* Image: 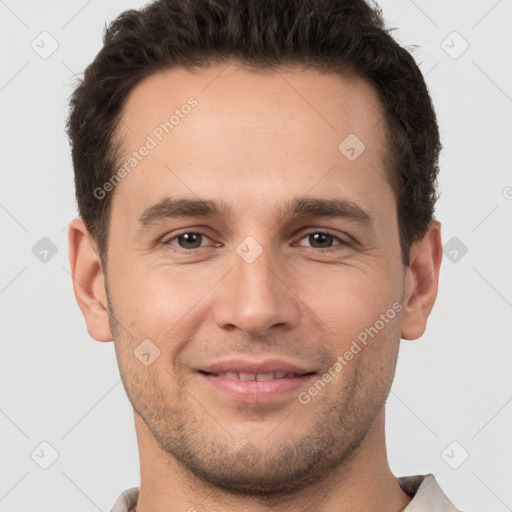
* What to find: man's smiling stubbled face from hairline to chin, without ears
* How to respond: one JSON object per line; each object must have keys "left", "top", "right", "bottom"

{"left": 108, "top": 66, "right": 404, "bottom": 492}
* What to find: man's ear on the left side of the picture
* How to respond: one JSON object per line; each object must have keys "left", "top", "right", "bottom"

{"left": 68, "top": 218, "right": 113, "bottom": 341}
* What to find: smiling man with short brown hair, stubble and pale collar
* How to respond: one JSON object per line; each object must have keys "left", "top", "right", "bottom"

{"left": 64, "top": 0, "right": 456, "bottom": 512}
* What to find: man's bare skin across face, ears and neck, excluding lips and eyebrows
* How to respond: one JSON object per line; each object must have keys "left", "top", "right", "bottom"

{"left": 69, "top": 63, "right": 442, "bottom": 512}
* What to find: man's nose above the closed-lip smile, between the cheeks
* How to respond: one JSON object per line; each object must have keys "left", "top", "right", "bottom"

{"left": 214, "top": 242, "right": 300, "bottom": 336}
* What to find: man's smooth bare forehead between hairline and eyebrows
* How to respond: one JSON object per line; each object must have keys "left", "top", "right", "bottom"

{"left": 114, "top": 64, "right": 390, "bottom": 224}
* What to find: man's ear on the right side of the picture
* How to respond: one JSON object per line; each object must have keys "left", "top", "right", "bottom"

{"left": 402, "top": 219, "right": 443, "bottom": 340}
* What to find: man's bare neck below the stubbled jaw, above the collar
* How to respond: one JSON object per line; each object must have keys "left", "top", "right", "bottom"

{"left": 131, "top": 408, "right": 411, "bottom": 512}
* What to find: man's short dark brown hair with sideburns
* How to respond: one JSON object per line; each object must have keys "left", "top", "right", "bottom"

{"left": 66, "top": 0, "right": 442, "bottom": 266}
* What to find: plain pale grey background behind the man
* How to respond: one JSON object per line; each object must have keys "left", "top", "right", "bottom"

{"left": 0, "top": 0, "right": 512, "bottom": 512}
